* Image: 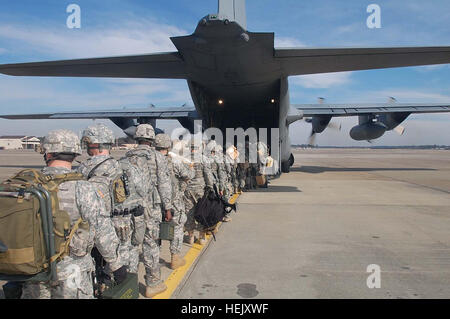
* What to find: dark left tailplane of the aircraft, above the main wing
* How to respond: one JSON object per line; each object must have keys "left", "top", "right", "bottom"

{"left": 0, "top": 52, "right": 186, "bottom": 79}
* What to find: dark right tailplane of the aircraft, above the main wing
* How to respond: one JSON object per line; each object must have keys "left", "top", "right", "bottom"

{"left": 275, "top": 46, "right": 450, "bottom": 76}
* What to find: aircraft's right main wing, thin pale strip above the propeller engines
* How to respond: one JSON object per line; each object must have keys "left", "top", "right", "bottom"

{"left": 292, "top": 103, "right": 450, "bottom": 117}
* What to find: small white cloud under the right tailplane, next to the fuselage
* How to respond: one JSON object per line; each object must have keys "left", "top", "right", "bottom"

{"left": 292, "top": 72, "right": 352, "bottom": 89}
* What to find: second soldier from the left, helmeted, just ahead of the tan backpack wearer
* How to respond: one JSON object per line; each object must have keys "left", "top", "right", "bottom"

{"left": 78, "top": 124, "right": 139, "bottom": 273}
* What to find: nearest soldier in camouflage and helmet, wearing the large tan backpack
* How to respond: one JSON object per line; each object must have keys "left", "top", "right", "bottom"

{"left": 22, "top": 130, "right": 127, "bottom": 299}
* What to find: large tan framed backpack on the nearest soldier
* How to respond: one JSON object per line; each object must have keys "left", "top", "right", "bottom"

{"left": 0, "top": 169, "right": 89, "bottom": 281}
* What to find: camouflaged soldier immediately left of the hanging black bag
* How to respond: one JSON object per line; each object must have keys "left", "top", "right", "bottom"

{"left": 185, "top": 139, "right": 214, "bottom": 245}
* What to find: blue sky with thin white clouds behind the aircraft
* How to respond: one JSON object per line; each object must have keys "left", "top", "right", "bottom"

{"left": 0, "top": 0, "right": 450, "bottom": 145}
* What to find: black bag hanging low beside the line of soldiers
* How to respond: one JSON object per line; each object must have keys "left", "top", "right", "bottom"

{"left": 194, "top": 185, "right": 236, "bottom": 230}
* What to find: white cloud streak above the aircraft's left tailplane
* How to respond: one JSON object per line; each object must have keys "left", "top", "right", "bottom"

{"left": 0, "top": 20, "right": 187, "bottom": 58}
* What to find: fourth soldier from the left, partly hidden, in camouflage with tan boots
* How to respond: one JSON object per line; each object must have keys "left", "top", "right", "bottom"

{"left": 155, "top": 134, "right": 194, "bottom": 269}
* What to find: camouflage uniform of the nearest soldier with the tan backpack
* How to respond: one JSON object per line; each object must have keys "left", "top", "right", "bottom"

{"left": 22, "top": 167, "right": 123, "bottom": 299}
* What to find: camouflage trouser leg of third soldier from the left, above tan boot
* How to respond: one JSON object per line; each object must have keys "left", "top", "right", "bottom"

{"left": 142, "top": 208, "right": 162, "bottom": 287}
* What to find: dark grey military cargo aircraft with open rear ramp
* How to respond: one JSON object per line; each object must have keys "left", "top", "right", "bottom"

{"left": 0, "top": 0, "right": 450, "bottom": 173}
